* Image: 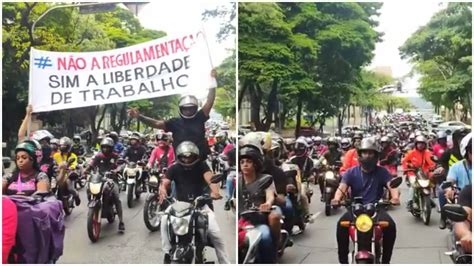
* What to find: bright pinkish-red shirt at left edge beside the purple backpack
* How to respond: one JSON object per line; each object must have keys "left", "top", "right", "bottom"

{"left": 2, "top": 196, "right": 18, "bottom": 264}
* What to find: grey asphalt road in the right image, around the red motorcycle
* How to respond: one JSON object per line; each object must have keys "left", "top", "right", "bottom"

{"left": 279, "top": 172, "right": 452, "bottom": 264}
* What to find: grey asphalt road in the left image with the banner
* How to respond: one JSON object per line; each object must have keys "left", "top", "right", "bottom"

{"left": 58, "top": 185, "right": 236, "bottom": 264}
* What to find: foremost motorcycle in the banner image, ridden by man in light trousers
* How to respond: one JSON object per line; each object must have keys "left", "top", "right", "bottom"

{"left": 159, "top": 176, "right": 220, "bottom": 264}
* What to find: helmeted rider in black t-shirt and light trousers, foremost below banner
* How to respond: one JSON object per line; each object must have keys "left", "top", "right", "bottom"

{"left": 160, "top": 141, "right": 230, "bottom": 264}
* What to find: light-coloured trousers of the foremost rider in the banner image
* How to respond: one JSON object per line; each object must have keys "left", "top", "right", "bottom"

{"left": 160, "top": 205, "right": 230, "bottom": 264}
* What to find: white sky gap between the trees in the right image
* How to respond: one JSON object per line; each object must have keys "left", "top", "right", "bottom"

{"left": 369, "top": 1, "right": 446, "bottom": 96}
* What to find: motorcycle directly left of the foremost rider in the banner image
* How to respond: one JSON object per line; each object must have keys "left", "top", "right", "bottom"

{"left": 143, "top": 168, "right": 171, "bottom": 232}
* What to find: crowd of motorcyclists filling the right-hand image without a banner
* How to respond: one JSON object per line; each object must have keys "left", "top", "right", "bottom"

{"left": 238, "top": 114, "right": 472, "bottom": 263}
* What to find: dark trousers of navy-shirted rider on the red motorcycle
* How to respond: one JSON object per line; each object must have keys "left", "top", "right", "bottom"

{"left": 336, "top": 211, "right": 397, "bottom": 264}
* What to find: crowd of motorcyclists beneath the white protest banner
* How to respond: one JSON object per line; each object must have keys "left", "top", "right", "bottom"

{"left": 3, "top": 70, "right": 241, "bottom": 263}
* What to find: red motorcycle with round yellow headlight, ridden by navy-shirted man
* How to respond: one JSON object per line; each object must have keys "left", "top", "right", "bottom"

{"left": 340, "top": 177, "right": 402, "bottom": 264}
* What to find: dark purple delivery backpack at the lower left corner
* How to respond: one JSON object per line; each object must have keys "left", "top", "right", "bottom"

{"left": 9, "top": 193, "right": 65, "bottom": 264}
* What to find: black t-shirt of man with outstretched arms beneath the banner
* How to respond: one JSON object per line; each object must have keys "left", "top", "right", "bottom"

{"left": 165, "top": 109, "right": 211, "bottom": 160}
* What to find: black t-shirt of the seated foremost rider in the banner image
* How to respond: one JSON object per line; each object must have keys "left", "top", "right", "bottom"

{"left": 166, "top": 162, "right": 211, "bottom": 202}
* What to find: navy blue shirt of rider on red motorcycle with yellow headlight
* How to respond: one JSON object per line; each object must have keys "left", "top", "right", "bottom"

{"left": 341, "top": 166, "right": 392, "bottom": 204}
